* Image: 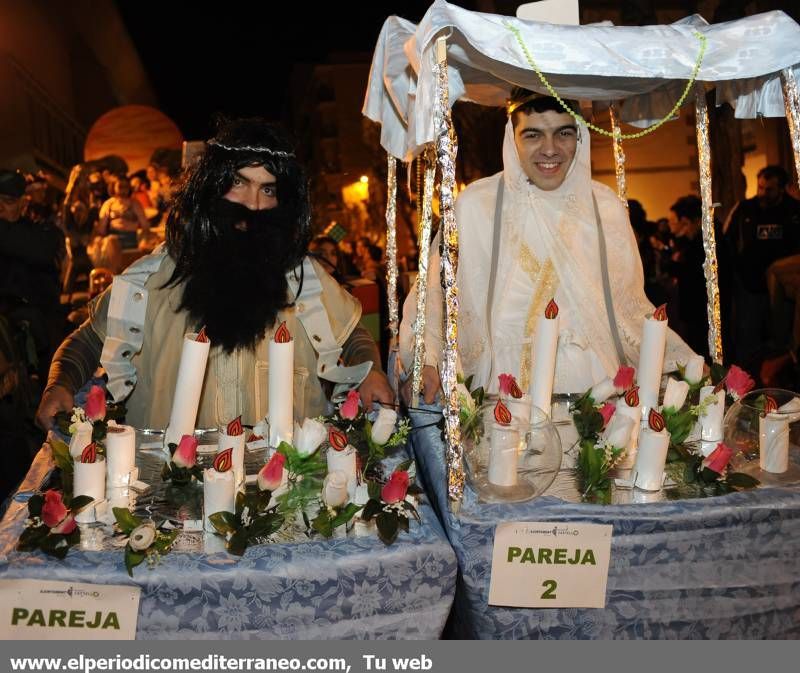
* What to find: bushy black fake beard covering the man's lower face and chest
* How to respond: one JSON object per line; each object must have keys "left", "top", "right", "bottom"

{"left": 181, "top": 199, "right": 296, "bottom": 352}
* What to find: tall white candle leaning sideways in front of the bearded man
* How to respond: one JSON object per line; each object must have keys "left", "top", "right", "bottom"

{"left": 164, "top": 333, "right": 211, "bottom": 446}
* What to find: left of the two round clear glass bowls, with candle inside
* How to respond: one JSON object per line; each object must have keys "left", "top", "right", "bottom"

{"left": 464, "top": 397, "right": 561, "bottom": 503}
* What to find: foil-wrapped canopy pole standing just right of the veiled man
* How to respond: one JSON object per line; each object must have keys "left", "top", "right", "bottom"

{"left": 695, "top": 84, "right": 722, "bottom": 364}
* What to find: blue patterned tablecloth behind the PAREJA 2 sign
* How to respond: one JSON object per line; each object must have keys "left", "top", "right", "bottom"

{"left": 412, "top": 412, "right": 800, "bottom": 639}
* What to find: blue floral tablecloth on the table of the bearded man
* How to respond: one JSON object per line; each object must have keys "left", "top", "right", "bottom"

{"left": 0, "top": 438, "right": 457, "bottom": 640}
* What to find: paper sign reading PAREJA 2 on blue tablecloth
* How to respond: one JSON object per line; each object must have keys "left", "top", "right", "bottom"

{"left": 489, "top": 521, "right": 612, "bottom": 608}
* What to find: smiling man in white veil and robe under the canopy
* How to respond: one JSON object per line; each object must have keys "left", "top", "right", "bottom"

{"left": 400, "top": 88, "right": 693, "bottom": 403}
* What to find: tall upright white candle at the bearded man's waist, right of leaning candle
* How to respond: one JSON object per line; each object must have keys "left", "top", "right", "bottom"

{"left": 268, "top": 322, "right": 294, "bottom": 446}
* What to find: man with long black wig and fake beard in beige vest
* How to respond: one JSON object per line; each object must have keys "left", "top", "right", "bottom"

{"left": 37, "top": 119, "right": 394, "bottom": 428}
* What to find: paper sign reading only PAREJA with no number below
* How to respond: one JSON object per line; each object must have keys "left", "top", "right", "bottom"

{"left": 0, "top": 579, "right": 140, "bottom": 640}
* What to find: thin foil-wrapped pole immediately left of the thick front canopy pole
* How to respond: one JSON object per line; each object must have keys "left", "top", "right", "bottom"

{"left": 411, "top": 148, "right": 441, "bottom": 407}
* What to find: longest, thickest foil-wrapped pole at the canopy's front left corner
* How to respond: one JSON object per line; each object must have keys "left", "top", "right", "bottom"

{"left": 433, "top": 37, "right": 464, "bottom": 511}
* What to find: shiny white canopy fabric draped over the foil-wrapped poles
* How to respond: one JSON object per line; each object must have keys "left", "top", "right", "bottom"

{"left": 363, "top": 0, "right": 800, "bottom": 159}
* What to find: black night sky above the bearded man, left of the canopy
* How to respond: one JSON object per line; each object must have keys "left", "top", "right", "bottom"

{"left": 112, "top": 0, "right": 472, "bottom": 139}
